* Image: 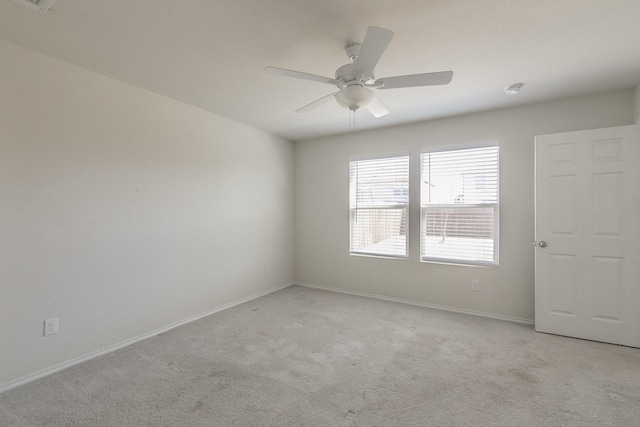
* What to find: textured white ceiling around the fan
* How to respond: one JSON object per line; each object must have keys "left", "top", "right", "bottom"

{"left": 0, "top": 0, "right": 640, "bottom": 140}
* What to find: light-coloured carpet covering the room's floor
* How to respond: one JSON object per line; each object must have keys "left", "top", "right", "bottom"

{"left": 0, "top": 286, "right": 640, "bottom": 427}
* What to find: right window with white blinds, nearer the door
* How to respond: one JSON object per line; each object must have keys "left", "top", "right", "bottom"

{"left": 421, "top": 146, "right": 499, "bottom": 265}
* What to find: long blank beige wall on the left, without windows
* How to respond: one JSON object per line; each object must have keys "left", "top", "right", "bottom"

{"left": 0, "top": 42, "right": 294, "bottom": 389}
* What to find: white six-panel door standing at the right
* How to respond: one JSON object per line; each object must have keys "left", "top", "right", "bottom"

{"left": 535, "top": 126, "right": 640, "bottom": 347}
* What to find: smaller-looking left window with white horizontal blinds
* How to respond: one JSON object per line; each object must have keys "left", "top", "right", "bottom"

{"left": 349, "top": 155, "right": 409, "bottom": 258}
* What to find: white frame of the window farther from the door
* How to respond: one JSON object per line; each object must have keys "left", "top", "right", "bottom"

{"left": 348, "top": 152, "right": 411, "bottom": 260}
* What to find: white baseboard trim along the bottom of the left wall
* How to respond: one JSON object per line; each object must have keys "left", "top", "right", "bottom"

{"left": 0, "top": 283, "right": 293, "bottom": 393}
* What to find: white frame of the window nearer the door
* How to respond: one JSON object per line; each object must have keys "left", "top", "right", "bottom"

{"left": 419, "top": 142, "right": 500, "bottom": 267}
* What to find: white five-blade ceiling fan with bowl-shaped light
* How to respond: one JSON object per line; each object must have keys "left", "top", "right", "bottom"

{"left": 264, "top": 27, "right": 453, "bottom": 117}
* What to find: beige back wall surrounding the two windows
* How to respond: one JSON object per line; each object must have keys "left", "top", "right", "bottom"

{"left": 295, "top": 91, "right": 633, "bottom": 320}
